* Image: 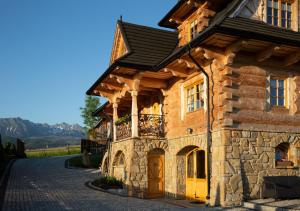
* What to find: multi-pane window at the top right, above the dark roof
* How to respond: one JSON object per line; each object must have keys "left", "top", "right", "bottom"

{"left": 267, "top": 0, "right": 292, "bottom": 29}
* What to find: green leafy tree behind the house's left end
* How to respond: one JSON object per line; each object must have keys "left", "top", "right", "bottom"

{"left": 80, "top": 96, "right": 100, "bottom": 135}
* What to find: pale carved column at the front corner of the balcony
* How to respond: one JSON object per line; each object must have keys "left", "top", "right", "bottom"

{"left": 131, "top": 91, "right": 139, "bottom": 138}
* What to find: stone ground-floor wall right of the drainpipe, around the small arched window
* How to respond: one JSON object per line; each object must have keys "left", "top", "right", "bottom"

{"left": 211, "top": 130, "right": 300, "bottom": 206}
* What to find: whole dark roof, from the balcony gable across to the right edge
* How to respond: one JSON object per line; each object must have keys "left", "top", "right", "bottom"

{"left": 87, "top": 0, "right": 300, "bottom": 94}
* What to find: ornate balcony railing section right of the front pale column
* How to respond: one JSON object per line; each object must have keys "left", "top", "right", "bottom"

{"left": 139, "top": 114, "right": 165, "bottom": 137}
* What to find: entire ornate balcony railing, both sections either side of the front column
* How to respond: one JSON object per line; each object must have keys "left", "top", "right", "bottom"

{"left": 115, "top": 114, "right": 165, "bottom": 140}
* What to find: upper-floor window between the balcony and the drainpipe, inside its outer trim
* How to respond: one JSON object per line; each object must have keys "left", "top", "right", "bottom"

{"left": 187, "top": 83, "right": 204, "bottom": 112}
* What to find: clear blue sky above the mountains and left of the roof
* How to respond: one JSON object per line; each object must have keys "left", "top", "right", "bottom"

{"left": 0, "top": 0, "right": 177, "bottom": 124}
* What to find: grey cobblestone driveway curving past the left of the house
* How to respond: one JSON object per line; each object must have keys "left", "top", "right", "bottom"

{"left": 2, "top": 157, "right": 182, "bottom": 211}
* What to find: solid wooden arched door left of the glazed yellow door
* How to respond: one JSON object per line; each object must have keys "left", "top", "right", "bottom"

{"left": 147, "top": 149, "right": 165, "bottom": 198}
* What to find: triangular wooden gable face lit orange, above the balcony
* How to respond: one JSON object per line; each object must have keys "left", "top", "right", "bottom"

{"left": 110, "top": 24, "right": 128, "bottom": 64}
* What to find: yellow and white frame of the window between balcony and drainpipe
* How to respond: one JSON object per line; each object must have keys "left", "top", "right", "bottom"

{"left": 185, "top": 81, "right": 205, "bottom": 113}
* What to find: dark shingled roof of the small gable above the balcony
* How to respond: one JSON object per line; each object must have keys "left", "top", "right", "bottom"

{"left": 87, "top": 21, "right": 178, "bottom": 94}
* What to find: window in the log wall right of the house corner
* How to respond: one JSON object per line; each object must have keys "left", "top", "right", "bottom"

{"left": 270, "top": 78, "right": 285, "bottom": 106}
